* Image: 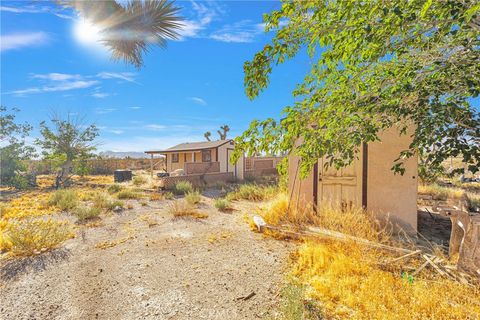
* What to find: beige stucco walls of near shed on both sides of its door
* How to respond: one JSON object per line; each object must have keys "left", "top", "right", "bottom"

{"left": 288, "top": 128, "right": 418, "bottom": 233}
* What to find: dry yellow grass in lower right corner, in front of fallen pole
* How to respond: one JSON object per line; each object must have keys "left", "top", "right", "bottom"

{"left": 291, "top": 242, "right": 480, "bottom": 320}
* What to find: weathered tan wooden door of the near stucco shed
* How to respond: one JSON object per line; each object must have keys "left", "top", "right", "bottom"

{"left": 317, "top": 154, "right": 362, "bottom": 211}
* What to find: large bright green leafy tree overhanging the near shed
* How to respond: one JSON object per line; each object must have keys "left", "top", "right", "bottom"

{"left": 236, "top": 0, "right": 480, "bottom": 176}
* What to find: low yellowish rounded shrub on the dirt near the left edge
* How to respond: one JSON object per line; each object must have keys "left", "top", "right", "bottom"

{"left": 6, "top": 219, "right": 74, "bottom": 256}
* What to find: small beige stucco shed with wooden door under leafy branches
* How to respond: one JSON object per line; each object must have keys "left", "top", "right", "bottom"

{"left": 288, "top": 128, "right": 418, "bottom": 233}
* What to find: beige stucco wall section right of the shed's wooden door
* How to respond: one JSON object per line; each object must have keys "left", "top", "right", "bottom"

{"left": 367, "top": 129, "right": 418, "bottom": 233}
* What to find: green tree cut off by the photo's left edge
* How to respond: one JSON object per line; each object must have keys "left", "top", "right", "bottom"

{"left": 0, "top": 106, "right": 35, "bottom": 188}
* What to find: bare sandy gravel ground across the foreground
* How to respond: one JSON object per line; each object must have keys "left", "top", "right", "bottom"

{"left": 0, "top": 197, "right": 293, "bottom": 319}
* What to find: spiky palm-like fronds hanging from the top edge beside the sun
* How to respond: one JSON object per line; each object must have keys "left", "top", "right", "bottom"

{"left": 57, "top": 0, "right": 182, "bottom": 68}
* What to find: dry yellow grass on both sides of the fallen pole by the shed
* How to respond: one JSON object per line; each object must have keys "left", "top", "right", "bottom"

{"left": 260, "top": 195, "right": 480, "bottom": 319}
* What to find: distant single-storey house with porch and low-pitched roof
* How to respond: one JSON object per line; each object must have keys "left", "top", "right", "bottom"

{"left": 145, "top": 140, "right": 245, "bottom": 186}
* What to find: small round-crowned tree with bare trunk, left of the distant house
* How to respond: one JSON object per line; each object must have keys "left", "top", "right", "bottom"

{"left": 35, "top": 116, "right": 98, "bottom": 188}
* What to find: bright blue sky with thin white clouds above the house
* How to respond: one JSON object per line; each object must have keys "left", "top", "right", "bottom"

{"left": 0, "top": 0, "right": 309, "bottom": 151}
